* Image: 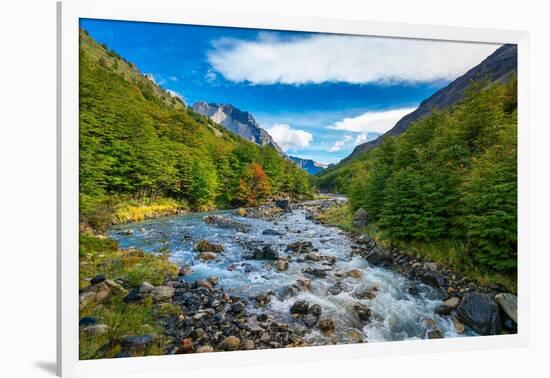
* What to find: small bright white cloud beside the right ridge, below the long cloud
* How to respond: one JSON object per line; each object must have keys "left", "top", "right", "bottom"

{"left": 328, "top": 108, "right": 416, "bottom": 134}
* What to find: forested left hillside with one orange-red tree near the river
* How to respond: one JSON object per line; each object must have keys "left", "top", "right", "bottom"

{"left": 80, "top": 30, "right": 310, "bottom": 228}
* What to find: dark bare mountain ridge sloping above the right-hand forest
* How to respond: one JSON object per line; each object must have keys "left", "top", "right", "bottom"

{"left": 343, "top": 45, "right": 517, "bottom": 161}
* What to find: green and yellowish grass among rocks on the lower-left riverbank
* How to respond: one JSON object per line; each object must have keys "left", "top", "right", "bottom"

{"left": 79, "top": 234, "right": 181, "bottom": 359}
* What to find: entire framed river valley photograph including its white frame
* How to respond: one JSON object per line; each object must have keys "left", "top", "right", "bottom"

{"left": 58, "top": 0, "right": 529, "bottom": 376}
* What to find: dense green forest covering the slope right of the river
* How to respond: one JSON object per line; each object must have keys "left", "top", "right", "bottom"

{"left": 316, "top": 79, "right": 517, "bottom": 274}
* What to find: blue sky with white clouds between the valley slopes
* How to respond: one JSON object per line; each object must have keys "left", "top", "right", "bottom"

{"left": 81, "top": 19, "right": 498, "bottom": 163}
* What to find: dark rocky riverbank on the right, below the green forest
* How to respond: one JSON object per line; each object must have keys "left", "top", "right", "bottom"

{"left": 308, "top": 199, "right": 517, "bottom": 336}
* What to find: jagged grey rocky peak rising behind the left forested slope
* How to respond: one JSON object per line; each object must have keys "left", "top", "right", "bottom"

{"left": 193, "top": 101, "right": 285, "bottom": 156}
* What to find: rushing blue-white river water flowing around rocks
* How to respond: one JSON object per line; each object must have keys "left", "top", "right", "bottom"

{"left": 109, "top": 202, "right": 472, "bottom": 345}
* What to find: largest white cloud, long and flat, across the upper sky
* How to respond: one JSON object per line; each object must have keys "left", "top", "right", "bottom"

{"left": 208, "top": 33, "right": 498, "bottom": 84}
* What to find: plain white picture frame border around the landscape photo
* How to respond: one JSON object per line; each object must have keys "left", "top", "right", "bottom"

{"left": 57, "top": 0, "right": 529, "bottom": 376}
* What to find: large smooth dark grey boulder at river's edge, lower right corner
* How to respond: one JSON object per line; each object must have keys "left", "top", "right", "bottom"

{"left": 456, "top": 292, "right": 500, "bottom": 335}
